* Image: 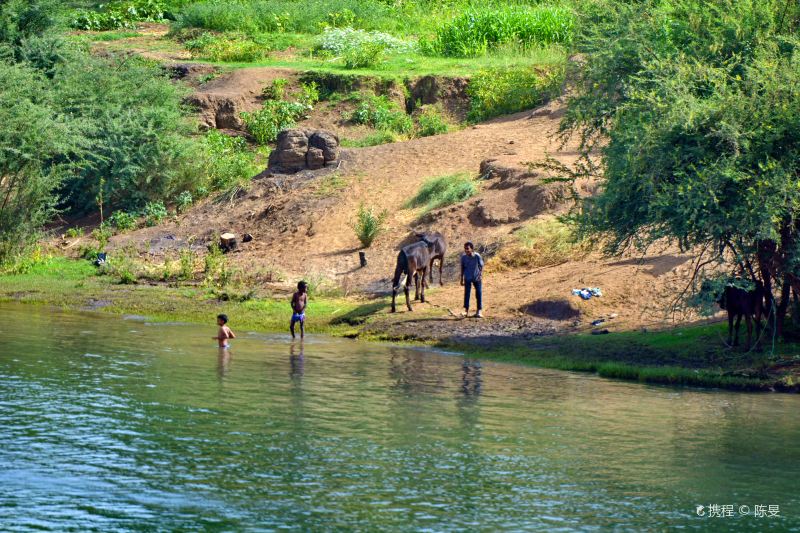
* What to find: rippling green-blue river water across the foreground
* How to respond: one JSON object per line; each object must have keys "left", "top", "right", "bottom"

{"left": 0, "top": 304, "right": 800, "bottom": 531}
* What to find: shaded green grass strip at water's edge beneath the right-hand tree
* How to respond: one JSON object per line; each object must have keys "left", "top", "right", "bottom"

{"left": 447, "top": 324, "right": 800, "bottom": 390}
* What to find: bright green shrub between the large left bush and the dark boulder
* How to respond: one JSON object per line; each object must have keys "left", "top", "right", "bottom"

{"left": 202, "top": 130, "right": 258, "bottom": 190}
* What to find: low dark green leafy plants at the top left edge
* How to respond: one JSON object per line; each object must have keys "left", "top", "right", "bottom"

{"left": 70, "top": 0, "right": 167, "bottom": 31}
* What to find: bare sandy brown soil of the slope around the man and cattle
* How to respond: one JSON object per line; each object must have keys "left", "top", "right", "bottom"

{"left": 113, "top": 85, "right": 691, "bottom": 339}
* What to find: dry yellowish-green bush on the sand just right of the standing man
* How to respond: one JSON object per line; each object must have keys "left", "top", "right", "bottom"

{"left": 492, "top": 218, "right": 589, "bottom": 270}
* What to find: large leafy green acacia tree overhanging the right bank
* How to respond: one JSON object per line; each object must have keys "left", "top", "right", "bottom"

{"left": 562, "top": 0, "right": 800, "bottom": 328}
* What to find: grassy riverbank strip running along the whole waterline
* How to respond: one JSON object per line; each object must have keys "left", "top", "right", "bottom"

{"left": 0, "top": 257, "right": 800, "bottom": 392}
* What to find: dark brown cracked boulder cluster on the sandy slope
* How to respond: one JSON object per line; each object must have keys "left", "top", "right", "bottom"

{"left": 268, "top": 129, "right": 339, "bottom": 174}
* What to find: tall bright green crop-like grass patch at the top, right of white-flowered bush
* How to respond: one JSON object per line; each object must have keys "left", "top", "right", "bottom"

{"left": 425, "top": 5, "right": 575, "bottom": 57}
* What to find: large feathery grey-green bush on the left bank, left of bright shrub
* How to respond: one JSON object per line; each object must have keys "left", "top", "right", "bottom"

{"left": 56, "top": 54, "right": 196, "bottom": 213}
